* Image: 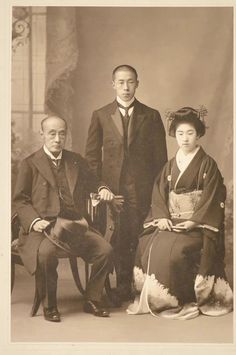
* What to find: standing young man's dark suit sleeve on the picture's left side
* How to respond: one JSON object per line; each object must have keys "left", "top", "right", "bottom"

{"left": 85, "top": 111, "right": 103, "bottom": 178}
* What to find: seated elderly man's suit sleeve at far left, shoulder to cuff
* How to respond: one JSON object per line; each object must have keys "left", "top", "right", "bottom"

{"left": 13, "top": 160, "right": 40, "bottom": 233}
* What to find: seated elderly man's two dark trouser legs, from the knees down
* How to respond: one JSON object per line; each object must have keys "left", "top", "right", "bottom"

{"left": 35, "top": 230, "right": 113, "bottom": 308}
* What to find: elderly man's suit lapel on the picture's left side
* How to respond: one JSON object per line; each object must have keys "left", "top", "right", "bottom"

{"left": 32, "top": 148, "right": 56, "bottom": 187}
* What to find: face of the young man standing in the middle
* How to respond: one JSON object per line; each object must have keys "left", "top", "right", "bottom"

{"left": 112, "top": 70, "right": 138, "bottom": 101}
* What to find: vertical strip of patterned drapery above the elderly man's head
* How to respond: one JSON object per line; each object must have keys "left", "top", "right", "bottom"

{"left": 45, "top": 7, "right": 78, "bottom": 134}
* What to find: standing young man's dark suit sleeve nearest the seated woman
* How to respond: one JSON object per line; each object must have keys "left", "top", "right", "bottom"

{"left": 151, "top": 111, "right": 167, "bottom": 176}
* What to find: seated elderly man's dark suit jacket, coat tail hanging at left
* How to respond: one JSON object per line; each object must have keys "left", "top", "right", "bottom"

{"left": 13, "top": 149, "right": 104, "bottom": 273}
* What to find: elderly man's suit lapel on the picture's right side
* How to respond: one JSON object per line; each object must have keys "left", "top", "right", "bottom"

{"left": 62, "top": 150, "right": 79, "bottom": 196}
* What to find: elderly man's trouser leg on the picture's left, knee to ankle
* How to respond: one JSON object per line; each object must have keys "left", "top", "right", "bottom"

{"left": 35, "top": 238, "right": 58, "bottom": 308}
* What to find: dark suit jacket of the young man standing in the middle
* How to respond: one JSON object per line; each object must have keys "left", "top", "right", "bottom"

{"left": 85, "top": 100, "right": 167, "bottom": 217}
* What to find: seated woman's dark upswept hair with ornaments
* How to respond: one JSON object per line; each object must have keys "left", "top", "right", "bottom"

{"left": 169, "top": 107, "right": 206, "bottom": 137}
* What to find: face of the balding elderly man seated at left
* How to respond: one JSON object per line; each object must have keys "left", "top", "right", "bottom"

{"left": 41, "top": 117, "right": 66, "bottom": 156}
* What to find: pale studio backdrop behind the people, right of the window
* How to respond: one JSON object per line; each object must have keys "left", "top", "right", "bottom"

{"left": 13, "top": 7, "right": 233, "bottom": 284}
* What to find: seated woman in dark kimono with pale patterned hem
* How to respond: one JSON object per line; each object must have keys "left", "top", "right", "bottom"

{"left": 127, "top": 107, "right": 233, "bottom": 319}
